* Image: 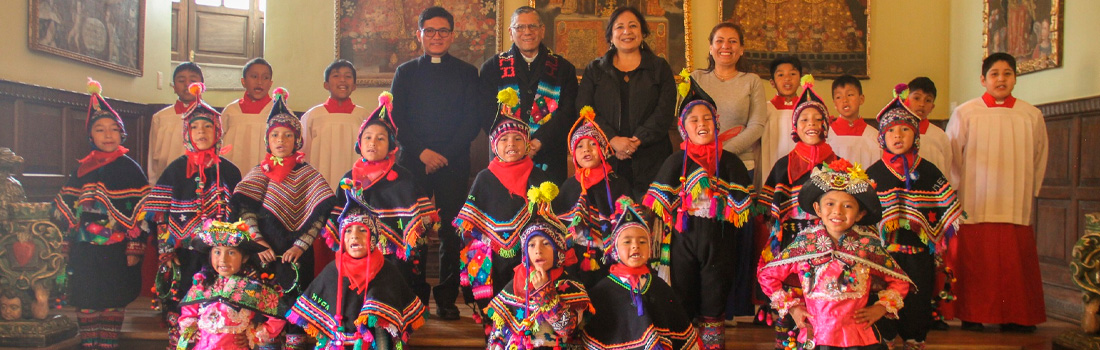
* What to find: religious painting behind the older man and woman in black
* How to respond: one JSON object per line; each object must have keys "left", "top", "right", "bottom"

{"left": 530, "top": 0, "right": 691, "bottom": 75}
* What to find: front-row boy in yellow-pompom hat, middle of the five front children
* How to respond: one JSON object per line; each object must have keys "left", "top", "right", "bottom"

{"left": 485, "top": 209, "right": 592, "bottom": 350}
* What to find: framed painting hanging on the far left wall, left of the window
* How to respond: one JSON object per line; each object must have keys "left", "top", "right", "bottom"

{"left": 26, "top": 0, "right": 145, "bottom": 76}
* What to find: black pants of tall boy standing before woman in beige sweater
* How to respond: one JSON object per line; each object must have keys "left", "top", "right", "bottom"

{"left": 669, "top": 217, "right": 737, "bottom": 319}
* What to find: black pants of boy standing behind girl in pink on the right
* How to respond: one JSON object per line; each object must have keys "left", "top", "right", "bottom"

{"left": 875, "top": 251, "right": 936, "bottom": 342}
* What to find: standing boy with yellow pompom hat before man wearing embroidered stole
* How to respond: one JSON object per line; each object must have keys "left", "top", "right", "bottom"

{"left": 453, "top": 88, "right": 554, "bottom": 322}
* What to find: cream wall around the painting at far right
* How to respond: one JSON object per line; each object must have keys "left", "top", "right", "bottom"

{"left": 949, "top": 0, "right": 1100, "bottom": 105}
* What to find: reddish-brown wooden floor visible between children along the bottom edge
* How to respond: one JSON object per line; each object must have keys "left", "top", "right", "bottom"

{"left": 45, "top": 298, "right": 1076, "bottom": 350}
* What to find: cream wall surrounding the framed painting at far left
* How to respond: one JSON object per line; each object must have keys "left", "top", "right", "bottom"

{"left": 0, "top": 0, "right": 175, "bottom": 103}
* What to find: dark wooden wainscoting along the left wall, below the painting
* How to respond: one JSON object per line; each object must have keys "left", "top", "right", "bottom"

{"left": 0, "top": 80, "right": 160, "bottom": 201}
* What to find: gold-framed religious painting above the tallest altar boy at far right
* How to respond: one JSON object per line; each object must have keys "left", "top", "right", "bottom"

{"left": 981, "top": 0, "right": 1063, "bottom": 74}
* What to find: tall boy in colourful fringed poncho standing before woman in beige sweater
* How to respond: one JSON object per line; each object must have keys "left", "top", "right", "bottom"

{"left": 644, "top": 79, "right": 755, "bottom": 349}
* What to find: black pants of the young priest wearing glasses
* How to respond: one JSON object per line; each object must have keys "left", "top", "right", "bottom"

{"left": 403, "top": 155, "right": 470, "bottom": 309}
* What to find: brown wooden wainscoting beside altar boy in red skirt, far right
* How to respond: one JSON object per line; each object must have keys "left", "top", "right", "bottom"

{"left": 1033, "top": 96, "right": 1100, "bottom": 324}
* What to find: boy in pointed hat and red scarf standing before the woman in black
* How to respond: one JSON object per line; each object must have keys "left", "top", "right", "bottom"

{"left": 553, "top": 106, "right": 630, "bottom": 286}
